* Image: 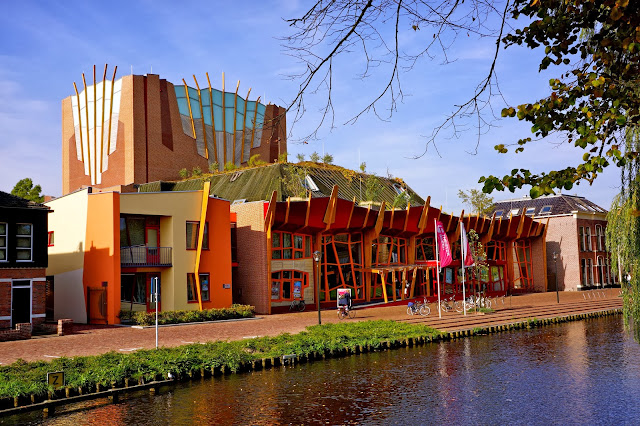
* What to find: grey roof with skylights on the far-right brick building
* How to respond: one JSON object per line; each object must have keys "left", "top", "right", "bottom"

{"left": 492, "top": 194, "right": 607, "bottom": 217}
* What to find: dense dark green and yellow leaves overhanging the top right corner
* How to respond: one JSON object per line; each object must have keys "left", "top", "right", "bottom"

{"left": 481, "top": 0, "right": 640, "bottom": 198}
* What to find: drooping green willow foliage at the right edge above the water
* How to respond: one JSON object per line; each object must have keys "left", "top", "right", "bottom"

{"left": 605, "top": 129, "right": 640, "bottom": 342}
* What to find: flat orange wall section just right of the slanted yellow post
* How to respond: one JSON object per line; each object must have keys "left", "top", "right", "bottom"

{"left": 199, "top": 198, "right": 232, "bottom": 309}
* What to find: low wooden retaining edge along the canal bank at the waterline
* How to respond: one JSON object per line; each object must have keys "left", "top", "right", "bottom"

{"left": 0, "top": 309, "right": 622, "bottom": 416}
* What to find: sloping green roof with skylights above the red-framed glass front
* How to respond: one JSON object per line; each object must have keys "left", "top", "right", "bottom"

{"left": 138, "top": 162, "right": 424, "bottom": 205}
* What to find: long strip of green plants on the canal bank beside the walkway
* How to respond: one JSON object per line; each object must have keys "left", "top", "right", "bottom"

{"left": 0, "top": 321, "right": 441, "bottom": 398}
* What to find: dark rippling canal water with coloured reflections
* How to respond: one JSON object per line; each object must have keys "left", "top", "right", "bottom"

{"left": 8, "top": 316, "right": 640, "bottom": 426}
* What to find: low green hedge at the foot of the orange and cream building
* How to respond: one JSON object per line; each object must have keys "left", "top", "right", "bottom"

{"left": 120, "top": 305, "right": 255, "bottom": 325}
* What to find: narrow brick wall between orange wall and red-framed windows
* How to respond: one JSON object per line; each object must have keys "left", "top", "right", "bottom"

{"left": 231, "top": 202, "right": 270, "bottom": 314}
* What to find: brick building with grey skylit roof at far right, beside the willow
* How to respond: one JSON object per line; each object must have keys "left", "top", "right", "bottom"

{"left": 494, "top": 194, "right": 618, "bottom": 291}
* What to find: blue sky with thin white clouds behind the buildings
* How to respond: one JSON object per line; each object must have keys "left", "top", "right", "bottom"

{"left": 0, "top": 0, "right": 620, "bottom": 214}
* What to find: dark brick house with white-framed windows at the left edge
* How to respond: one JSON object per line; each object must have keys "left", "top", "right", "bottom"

{"left": 0, "top": 191, "right": 50, "bottom": 329}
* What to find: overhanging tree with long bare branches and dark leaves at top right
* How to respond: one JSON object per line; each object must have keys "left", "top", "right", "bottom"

{"left": 284, "top": 0, "right": 640, "bottom": 198}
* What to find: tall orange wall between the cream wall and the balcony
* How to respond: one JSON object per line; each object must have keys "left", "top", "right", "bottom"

{"left": 83, "top": 192, "right": 120, "bottom": 324}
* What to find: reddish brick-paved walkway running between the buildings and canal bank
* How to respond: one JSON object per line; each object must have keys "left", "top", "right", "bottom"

{"left": 0, "top": 289, "right": 622, "bottom": 365}
